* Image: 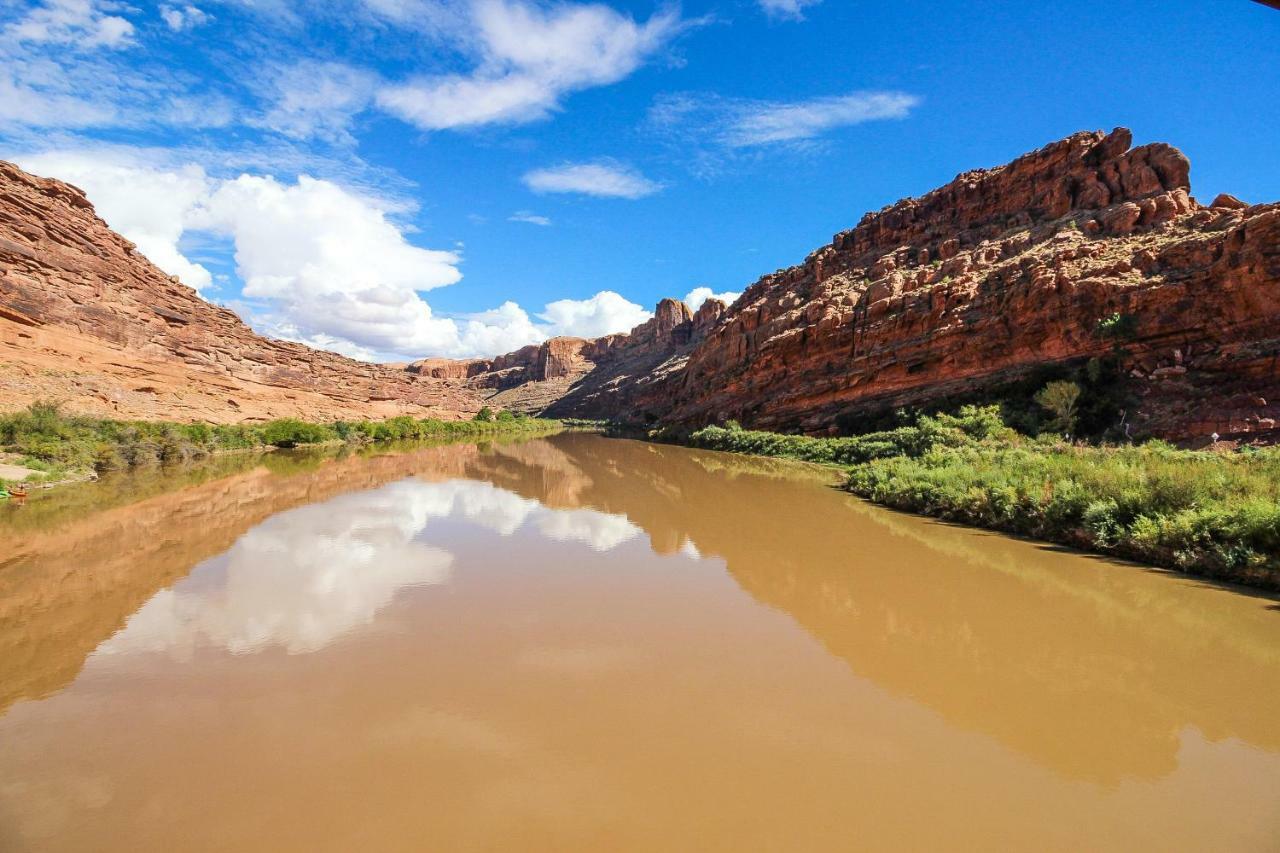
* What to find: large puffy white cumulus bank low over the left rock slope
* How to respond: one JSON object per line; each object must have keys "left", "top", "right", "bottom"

{"left": 10, "top": 151, "right": 649, "bottom": 360}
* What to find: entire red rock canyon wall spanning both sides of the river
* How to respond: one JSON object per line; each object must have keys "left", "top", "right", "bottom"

{"left": 0, "top": 128, "right": 1280, "bottom": 439}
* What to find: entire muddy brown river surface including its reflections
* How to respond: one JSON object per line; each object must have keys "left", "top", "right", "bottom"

{"left": 0, "top": 434, "right": 1280, "bottom": 850}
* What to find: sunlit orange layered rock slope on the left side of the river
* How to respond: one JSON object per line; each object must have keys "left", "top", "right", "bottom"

{"left": 0, "top": 163, "right": 483, "bottom": 421}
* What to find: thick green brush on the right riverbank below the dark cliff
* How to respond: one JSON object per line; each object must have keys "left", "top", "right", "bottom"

{"left": 687, "top": 406, "right": 1280, "bottom": 587}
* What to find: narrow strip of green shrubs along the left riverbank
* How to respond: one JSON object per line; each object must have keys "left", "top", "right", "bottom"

{"left": 0, "top": 402, "right": 561, "bottom": 480}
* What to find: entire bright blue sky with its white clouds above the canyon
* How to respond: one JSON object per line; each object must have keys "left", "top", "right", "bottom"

{"left": 0, "top": 0, "right": 1280, "bottom": 359}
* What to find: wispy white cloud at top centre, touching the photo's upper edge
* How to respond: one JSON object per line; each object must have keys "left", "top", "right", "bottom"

{"left": 378, "top": 0, "right": 681, "bottom": 131}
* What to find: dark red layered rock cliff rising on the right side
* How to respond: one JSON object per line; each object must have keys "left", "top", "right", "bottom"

{"left": 522, "top": 128, "right": 1280, "bottom": 439}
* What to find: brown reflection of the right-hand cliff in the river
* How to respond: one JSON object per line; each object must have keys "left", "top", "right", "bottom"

{"left": 474, "top": 435, "right": 1280, "bottom": 784}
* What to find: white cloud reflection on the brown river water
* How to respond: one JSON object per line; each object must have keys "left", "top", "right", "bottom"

{"left": 97, "top": 479, "right": 640, "bottom": 658}
